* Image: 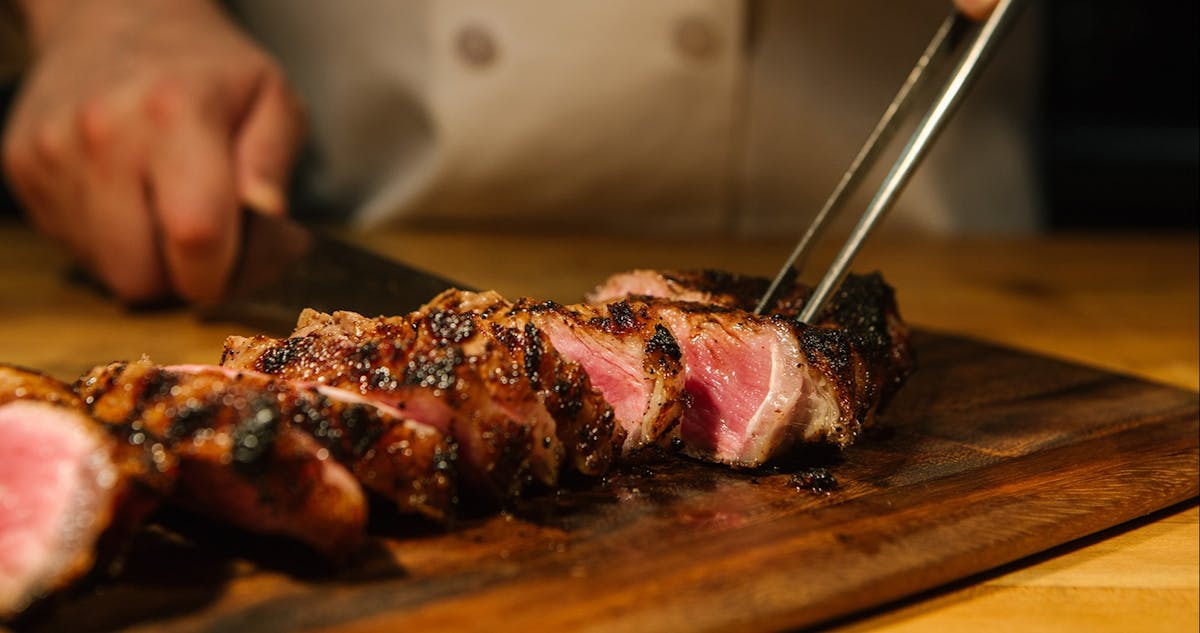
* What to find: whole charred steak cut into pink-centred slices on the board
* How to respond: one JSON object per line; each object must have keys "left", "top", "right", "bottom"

{"left": 0, "top": 270, "right": 914, "bottom": 617}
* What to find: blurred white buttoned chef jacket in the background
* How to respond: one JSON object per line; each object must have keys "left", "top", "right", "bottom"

{"left": 235, "top": 0, "right": 1039, "bottom": 235}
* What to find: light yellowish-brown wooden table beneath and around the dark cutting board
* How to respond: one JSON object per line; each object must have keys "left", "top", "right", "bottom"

{"left": 0, "top": 223, "right": 1200, "bottom": 632}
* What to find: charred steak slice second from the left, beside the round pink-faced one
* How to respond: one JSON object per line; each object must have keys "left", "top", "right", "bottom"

{"left": 76, "top": 361, "right": 366, "bottom": 559}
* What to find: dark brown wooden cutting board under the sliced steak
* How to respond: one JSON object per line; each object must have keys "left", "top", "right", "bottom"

{"left": 11, "top": 332, "right": 1200, "bottom": 632}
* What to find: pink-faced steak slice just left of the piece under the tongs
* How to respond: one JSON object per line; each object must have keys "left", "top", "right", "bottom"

{"left": 512, "top": 300, "right": 685, "bottom": 453}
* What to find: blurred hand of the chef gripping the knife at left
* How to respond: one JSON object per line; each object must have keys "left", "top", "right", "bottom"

{"left": 4, "top": 0, "right": 304, "bottom": 302}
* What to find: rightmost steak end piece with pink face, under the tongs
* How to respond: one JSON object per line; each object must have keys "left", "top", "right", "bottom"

{"left": 589, "top": 271, "right": 914, "bottom": 466}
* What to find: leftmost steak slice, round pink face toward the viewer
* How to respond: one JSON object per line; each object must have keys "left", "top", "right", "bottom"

{"left": 0, "top": 364, "right": 162, "bottom": 619}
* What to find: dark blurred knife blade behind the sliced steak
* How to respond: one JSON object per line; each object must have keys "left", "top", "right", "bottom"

{"left": 197, "top": 211, "right": 467, "bottom": 333}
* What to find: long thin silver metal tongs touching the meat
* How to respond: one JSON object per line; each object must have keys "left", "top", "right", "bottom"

{"left": 755, "top": 0, "right": 1022, "bottom": 322}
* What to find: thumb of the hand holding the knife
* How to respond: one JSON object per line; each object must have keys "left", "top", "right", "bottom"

{"left": 235, "top": 77, "right": 305, "bottom": 216}
